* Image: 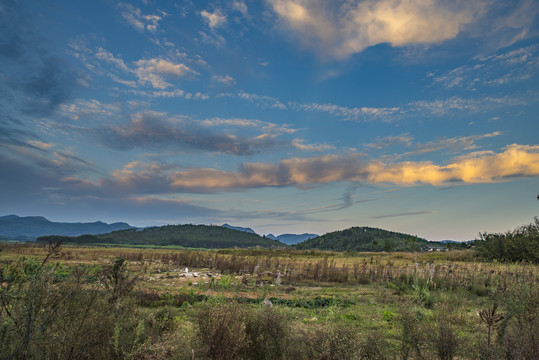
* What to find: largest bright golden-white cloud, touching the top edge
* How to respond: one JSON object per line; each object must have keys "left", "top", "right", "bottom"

{"left": 267, "top": 0, "right": 537, "bottom": 59}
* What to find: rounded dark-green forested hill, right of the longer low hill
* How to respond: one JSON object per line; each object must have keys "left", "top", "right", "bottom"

{"left": 293, "top": 227, "right": 428, "bottom": 251}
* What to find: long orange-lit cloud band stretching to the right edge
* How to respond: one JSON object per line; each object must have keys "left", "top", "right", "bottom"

{"left": 70, "top": 144, "right": 539, "bottom": 193}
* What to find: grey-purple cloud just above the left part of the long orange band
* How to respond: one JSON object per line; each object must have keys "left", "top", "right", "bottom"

{"left": 92, "top": 111, "right": 283, "bottom": 155}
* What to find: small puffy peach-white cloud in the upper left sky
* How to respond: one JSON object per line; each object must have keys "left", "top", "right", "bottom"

{"left": 134, "top": 58, "right": 198, "bottom": 89}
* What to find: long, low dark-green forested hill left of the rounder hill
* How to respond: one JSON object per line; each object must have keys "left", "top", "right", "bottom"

{"left": 37, "top": 225, "right": 286, "bottom": 249}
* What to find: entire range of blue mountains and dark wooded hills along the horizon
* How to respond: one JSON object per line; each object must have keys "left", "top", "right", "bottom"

{"left": 0, "top": 215, "right": 460, "bottom": 251}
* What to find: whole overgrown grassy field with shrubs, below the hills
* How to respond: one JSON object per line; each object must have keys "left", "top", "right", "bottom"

{"left": 0, "top": 243, "right": 539, "bottom": 359}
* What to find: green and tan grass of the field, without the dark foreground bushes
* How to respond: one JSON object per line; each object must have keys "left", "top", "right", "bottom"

{"left": 0, "top": 244, "right": 539, "bottom": 360}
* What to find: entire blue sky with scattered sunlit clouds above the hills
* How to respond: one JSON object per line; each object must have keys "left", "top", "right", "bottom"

{"left": 0, "top": 0, "right": 539, "bottom": 240}
